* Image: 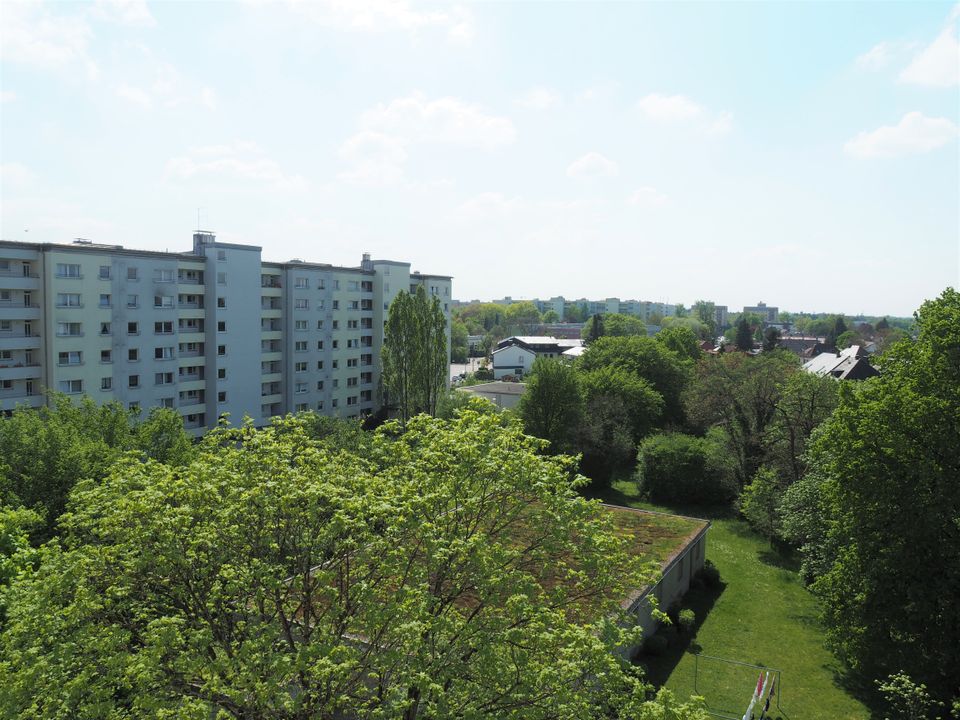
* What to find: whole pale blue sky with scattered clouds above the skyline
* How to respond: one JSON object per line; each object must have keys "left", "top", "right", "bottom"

{"left": 0, "top": 0, "right": 960, "bottom": 315}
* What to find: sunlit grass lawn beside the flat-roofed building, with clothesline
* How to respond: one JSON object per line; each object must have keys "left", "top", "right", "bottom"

{"left": 588, "top": 481, "right": 870, "bottom": 720}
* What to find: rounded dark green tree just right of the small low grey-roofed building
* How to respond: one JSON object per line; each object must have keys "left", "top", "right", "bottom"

{"left": 517, "top": 357, "right": 583, "bottom": 453}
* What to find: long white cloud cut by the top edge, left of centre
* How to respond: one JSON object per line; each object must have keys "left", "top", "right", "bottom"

{"left": 264, "top": 0, "right": 474, "bottom": 42}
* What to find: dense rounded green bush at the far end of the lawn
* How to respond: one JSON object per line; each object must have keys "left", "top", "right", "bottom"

{"left": 636, "top": 433, "right": 735, "bottom": 504}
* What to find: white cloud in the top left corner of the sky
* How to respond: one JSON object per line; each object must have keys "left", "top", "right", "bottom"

{"left": 0, "top": 2, "right": 98, "bottom": 78}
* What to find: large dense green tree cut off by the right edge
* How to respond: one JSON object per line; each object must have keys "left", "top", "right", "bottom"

{"left": 808, "top": 289, "right": 960, "bottom": 700}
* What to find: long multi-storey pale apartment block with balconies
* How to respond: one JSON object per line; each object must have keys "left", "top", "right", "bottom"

{"left": 0, "top": 232, "right": 452, "bottom": 434}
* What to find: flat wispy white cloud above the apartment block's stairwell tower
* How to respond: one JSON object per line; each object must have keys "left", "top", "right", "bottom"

{"left": 164, "top": 142, "right": 307, "bottom": 191}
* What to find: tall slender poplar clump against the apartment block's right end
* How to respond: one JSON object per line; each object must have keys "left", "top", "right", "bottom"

{"left": 381, "top": 285, "right": 450, "bottom": 422}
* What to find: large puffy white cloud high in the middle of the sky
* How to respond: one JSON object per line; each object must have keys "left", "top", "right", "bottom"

{"left": 360, "top": 93, "right": 517, "bottom": 149}
